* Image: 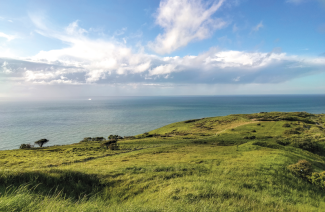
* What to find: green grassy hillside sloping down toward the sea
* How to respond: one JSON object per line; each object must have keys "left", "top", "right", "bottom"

{"left": 0, "top": 112, "right": 325, "bottom": 211}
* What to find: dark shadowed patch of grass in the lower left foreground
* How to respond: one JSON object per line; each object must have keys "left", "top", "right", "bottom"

{"left": 0, "top": 169, "right": 106, "bottom": 199}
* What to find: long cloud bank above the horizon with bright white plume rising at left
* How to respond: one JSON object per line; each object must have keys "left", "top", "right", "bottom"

{"left": 0, "top": 18, "right": 325, "bottom": 86}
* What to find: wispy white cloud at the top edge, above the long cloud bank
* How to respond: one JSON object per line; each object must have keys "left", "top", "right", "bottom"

{"left": 148, "top": 0, "right": 226, "bottom": 54}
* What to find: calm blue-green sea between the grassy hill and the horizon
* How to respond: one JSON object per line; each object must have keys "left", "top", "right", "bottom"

{"left": 0, "top": 95, "right": 325, "bottom": 150}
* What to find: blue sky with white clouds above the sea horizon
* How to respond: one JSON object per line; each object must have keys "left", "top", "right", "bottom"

{"left": 0, "top": 0, "right": 325, "bottom": 99}
